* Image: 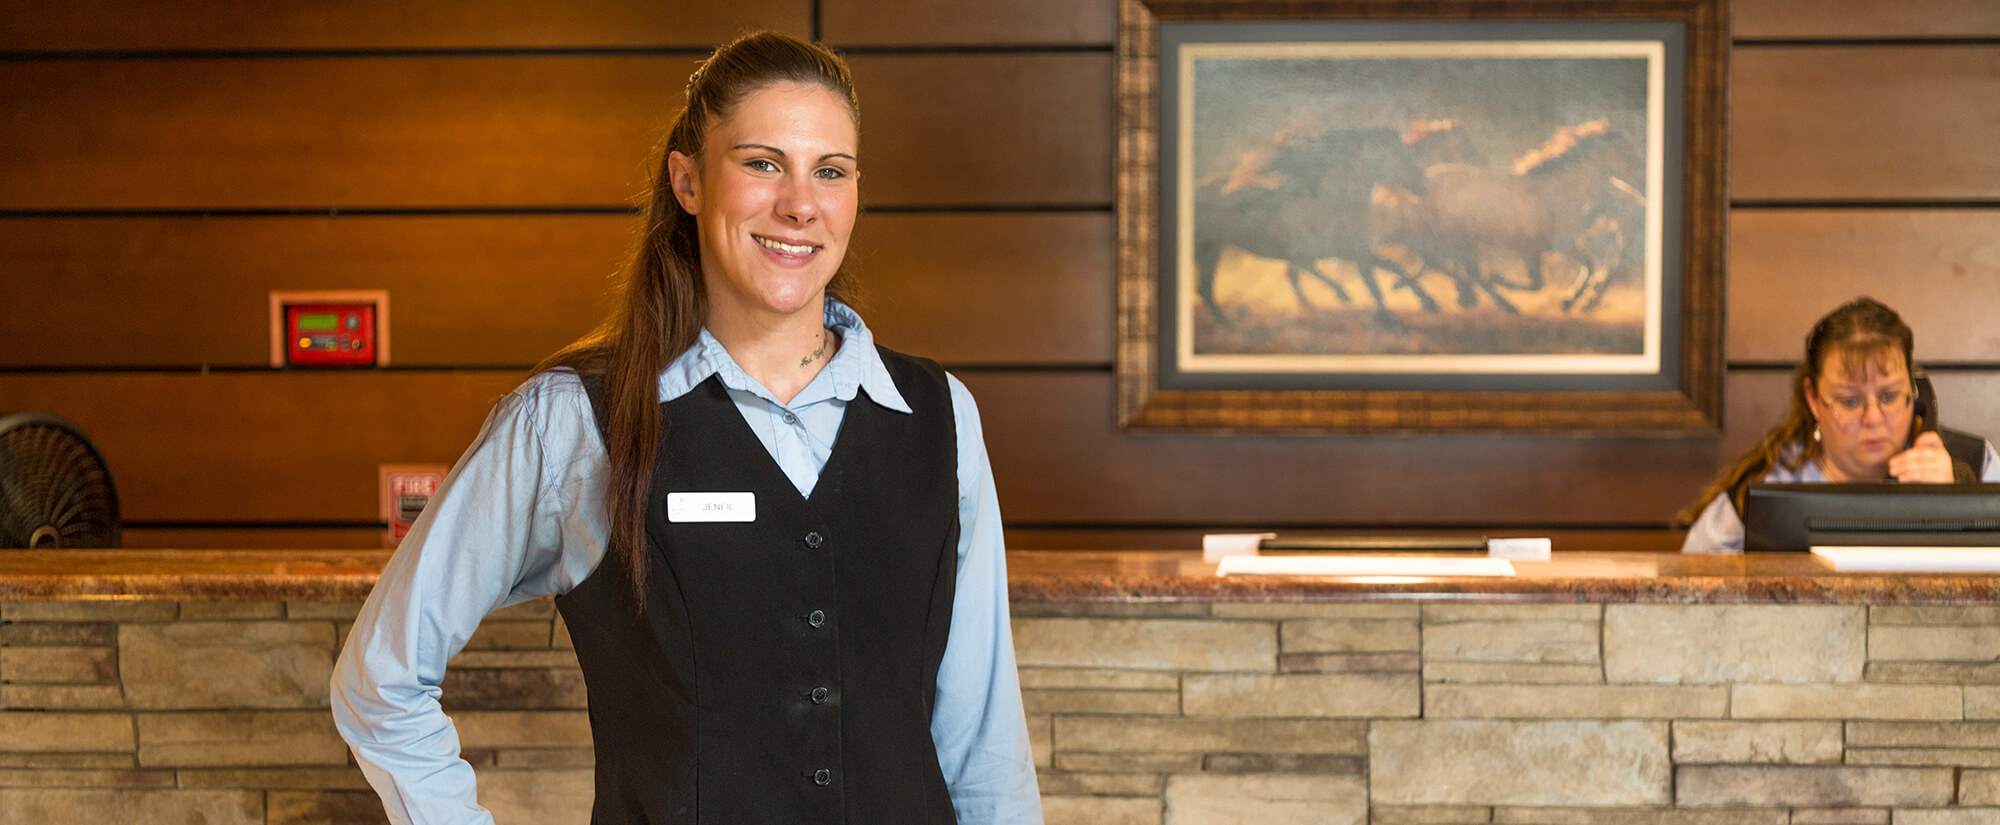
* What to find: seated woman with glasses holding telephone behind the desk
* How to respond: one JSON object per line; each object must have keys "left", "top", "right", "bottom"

{"left": 1676, "top": 296, "right": 2000, "bottom": 553}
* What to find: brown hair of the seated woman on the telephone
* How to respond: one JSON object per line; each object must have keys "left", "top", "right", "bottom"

{"left": 1674, "top": 294, "right": 1916, "bottom": 527}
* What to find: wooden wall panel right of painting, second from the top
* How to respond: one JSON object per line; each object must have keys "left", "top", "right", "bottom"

{"left": 1728, "top": 46, "right": 2000, "bottom": 200}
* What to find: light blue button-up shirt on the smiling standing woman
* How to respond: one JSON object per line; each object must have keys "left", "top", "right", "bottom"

{"left": 332, "top": 300, "right": 1042, "bottom": 825}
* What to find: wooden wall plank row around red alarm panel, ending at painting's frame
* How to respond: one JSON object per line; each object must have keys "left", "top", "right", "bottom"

{"left": 0, "top": 212, "right": 1112, "bottom": 366}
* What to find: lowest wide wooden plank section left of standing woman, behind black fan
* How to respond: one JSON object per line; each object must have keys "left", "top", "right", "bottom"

{"left": 0, "top": 370, "right": 522, "bottom": 523}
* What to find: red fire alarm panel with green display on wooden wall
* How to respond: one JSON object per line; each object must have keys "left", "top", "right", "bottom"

{"left": 270, "top": 290, "right": 388, "bottom": 366}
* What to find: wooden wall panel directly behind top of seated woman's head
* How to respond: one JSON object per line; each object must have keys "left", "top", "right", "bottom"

{"left": 1724, "top": 210, "right": 2000, "bottom": 362}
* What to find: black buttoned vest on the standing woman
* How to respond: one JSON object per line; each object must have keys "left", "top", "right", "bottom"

{"left": 556, "top": 350, "right": 958, "bottom": 825}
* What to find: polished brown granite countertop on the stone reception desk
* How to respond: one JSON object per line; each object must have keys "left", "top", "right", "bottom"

{"left": 0, "top": 551, "right": 2000, "bottom": 605}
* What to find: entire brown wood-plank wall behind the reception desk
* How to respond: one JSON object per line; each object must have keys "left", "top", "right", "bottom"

{"left": 0, "top": 0, "right": 2000, "bottom": 549}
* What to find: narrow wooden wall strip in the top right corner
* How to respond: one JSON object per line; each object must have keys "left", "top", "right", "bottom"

{"left": 1730, "top": 0, "right": 2000, "bottom": 40}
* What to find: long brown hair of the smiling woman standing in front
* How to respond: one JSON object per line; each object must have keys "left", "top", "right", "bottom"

{"left": 534, "top": 32, "right": 860, "bottom": 605}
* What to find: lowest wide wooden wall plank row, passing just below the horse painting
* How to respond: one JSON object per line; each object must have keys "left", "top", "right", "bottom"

{"left": 11, "top": 370, "right": 2000, "bottom": 531}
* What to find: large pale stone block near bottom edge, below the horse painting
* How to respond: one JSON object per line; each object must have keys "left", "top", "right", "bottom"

{"left": 1368, "top": 721, "right": 1670, "bottom": 805}
